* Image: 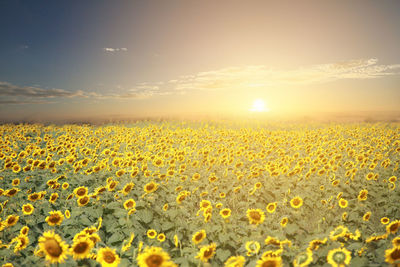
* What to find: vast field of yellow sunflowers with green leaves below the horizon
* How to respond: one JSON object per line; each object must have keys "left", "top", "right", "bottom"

{"left": 0, "top": 121, "right": 400, "bottom": 267}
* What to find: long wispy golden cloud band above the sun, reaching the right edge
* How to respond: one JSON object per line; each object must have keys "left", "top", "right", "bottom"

{"left": 127, "top": 58, "right": 400, "bottom": 95}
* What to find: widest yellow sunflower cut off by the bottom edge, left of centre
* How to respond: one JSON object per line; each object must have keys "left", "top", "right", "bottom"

{"left": 136, "top": 247, "right": 176, "bottom": 267}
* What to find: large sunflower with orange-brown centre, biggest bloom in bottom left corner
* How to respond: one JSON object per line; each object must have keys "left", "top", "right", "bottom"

{"left": 39, "top": 231, "right": 68, "bottom": 263}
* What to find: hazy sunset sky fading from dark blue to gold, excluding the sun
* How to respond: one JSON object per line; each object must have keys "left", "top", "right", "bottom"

{"left": 0, "top": 0, "right": 400, "bottom": 122}
